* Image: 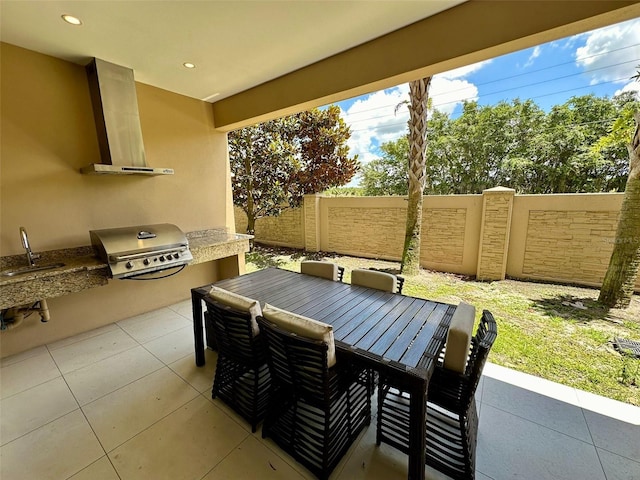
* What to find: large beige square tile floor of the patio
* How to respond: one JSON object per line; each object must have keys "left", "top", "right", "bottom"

{"left": 0, "top": 301, "right": 640, "bottom": 480}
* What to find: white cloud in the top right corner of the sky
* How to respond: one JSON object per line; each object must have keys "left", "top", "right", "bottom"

{"left": 575, "top": 19, "right": 640, "bottom": 85}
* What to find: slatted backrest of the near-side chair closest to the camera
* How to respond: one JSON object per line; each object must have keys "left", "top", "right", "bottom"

{"left": 257, "top": 317, "right": 329, "bottom": 403}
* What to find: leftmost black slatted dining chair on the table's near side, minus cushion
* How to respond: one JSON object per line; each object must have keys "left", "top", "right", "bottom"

{"left": 204, "top": 297, "right": 271, "bottom": 432}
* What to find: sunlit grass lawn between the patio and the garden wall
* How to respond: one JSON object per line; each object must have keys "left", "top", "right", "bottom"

{"left": 246, "top": 245, "right": 640, "bottom": 406}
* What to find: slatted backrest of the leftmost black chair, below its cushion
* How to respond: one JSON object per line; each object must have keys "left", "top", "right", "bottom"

{"left": 204, "top": 297, "right": 266, "bottom": 364}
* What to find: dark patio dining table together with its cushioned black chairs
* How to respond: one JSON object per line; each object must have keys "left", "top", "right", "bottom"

{"left": 192, "top": 261, "right": 497, "bottom": 479}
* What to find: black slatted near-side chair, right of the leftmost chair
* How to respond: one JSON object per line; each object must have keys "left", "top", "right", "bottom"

{"left": 258, "top": 307, "right": 371, "bottom": 480}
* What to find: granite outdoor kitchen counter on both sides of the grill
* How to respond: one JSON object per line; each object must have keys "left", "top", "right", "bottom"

{"left": 0, "top": 229, "right": 251, "bottom": 309}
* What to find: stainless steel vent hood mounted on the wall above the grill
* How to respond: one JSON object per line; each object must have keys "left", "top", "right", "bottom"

{"left": 80, "top": 58, "right": 173, "bottom": 175}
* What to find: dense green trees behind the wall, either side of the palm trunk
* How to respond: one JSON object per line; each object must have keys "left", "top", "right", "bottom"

{"left": 361, "top": 92, "right": 640, "bottom": 195}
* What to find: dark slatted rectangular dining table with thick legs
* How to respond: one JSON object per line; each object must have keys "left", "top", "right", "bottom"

{"left": 191, "top": 268, "right": 456, "bottom": 480}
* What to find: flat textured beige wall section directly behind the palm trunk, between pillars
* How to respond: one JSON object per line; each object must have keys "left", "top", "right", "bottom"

{"left": 319, "top": 195, "right": 482, "bottom": 275}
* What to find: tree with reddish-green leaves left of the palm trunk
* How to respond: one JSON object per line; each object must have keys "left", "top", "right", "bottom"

{"left": 228, "top": 105, "right": 359, "bottom": 235}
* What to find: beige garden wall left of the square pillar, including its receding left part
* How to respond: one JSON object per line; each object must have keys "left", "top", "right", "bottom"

{"left": 236, "top": 195, "right": 482, "bottom": 275}
